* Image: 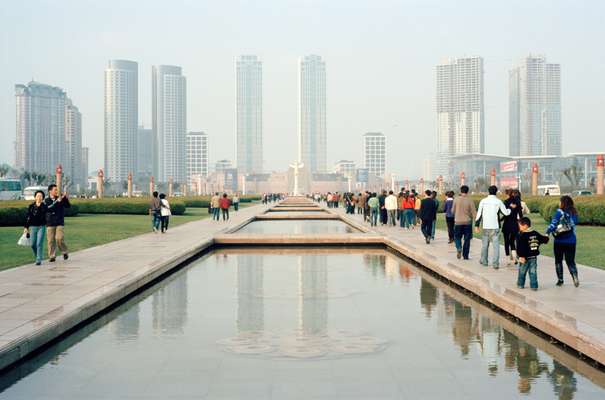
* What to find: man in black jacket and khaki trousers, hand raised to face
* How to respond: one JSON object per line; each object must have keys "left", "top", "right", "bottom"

{"left": 44, "top": 184, "right": 71, "bottom": 262}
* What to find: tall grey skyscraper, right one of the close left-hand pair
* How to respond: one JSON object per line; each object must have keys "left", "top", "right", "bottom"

{"left": 152, "top": 65, "right": 187, "bottom": 183}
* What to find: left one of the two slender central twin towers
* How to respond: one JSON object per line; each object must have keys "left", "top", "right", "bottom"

{"left": 237, "top": 55, "right": 263, "bottom": 174}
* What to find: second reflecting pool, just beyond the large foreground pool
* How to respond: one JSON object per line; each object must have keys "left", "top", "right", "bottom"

{"left": 236, "top": 219, "right": 359, "bottom": 235}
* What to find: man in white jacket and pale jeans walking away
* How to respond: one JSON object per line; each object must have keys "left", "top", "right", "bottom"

{"left": 475, "top": 186, "right": 516, "bottom": 269}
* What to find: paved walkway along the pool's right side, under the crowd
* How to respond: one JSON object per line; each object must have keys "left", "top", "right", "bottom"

{"left": 326, "top": 208, "right": 605, "bottom": 365}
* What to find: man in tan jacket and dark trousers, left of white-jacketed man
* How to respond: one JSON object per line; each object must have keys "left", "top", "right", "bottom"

{"left": 451, "top": 185, "right": 476, "bottom": 260}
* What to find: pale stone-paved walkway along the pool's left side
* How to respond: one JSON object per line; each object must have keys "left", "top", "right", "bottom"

{"left": 0, "top": 205, "right": 267, "bottom": 369}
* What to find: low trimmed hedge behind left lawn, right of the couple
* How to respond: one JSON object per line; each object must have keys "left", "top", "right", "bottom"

{"left": 72, "top": 197, "right": 186, "bottom": 215}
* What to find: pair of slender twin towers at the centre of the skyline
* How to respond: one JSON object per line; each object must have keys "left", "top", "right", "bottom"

{"left": 237, "top": 55, "right": 327, "bottom": 174}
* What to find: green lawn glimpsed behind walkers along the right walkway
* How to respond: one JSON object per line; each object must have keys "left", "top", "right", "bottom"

{"left": 437, "top": 214, "right": 605, "bottom": 269}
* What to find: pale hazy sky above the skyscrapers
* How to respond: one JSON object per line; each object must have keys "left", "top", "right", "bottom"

{"left": 0, "top": 0, "right": 605, "bottom": 177}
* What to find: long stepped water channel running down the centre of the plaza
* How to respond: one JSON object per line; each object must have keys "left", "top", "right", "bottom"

{"left": 0, "top": 198, "right": 605, "bottom": 399}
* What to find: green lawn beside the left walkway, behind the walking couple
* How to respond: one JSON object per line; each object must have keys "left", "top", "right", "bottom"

{"left": 0, "top": 208, "right": 216, "bottom": 270}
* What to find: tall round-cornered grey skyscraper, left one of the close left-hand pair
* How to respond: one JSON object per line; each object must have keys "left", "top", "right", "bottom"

{"left": 105, "top": 60, "right": 139, "bottom": 182}
